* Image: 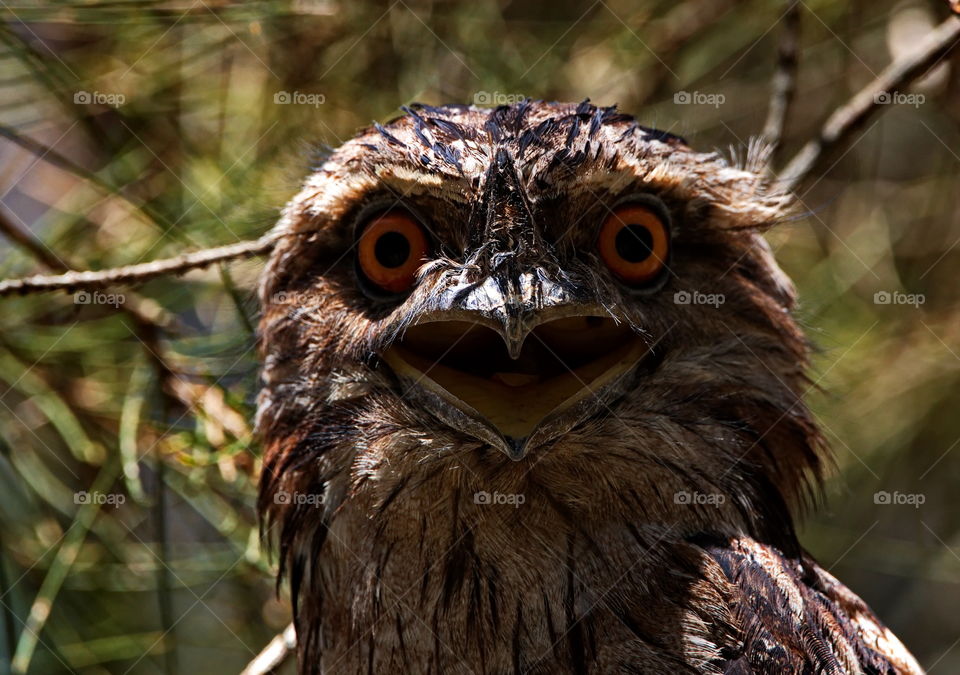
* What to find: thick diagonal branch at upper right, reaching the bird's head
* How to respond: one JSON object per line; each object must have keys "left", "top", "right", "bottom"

{"left": 778, "top": 17, "right": 960, "bottom": 191}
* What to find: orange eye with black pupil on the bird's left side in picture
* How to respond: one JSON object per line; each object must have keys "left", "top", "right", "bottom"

{"left": 357, "top": 211, "right": 427, "bottom": 293}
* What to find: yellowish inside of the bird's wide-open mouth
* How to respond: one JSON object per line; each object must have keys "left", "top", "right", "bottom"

{"left": 383, "top": 315, "right": 650, "bottom": 459}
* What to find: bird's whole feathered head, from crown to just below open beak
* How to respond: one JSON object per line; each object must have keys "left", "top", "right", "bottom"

{"left": 260, "top": 103, "right": 817, "bottom": 528}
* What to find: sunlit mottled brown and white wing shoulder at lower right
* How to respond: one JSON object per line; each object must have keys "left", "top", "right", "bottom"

{"left": 690, "top": 536, "right": 923, "bottom": 675}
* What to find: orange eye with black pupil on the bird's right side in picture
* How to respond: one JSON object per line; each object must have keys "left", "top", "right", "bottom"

{"left": 597, "top": 204, "right": 670, "bottom": 285}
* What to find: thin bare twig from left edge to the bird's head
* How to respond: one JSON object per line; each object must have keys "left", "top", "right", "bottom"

{"left": 0, "top": 232, "right": 279, "bottom": 297}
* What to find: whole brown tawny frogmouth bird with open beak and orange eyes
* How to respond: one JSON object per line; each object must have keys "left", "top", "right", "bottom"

{"left": 256, "top": 99, "right": 922, "bottom": 674}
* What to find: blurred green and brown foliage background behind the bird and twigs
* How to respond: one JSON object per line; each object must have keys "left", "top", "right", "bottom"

{"left": 0, "top": 0, "right": 960, "bottom": 674}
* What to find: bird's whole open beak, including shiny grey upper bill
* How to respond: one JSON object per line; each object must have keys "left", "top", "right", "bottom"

{"left": 383, "top": 272, "right": 651, "bottom": 460}
